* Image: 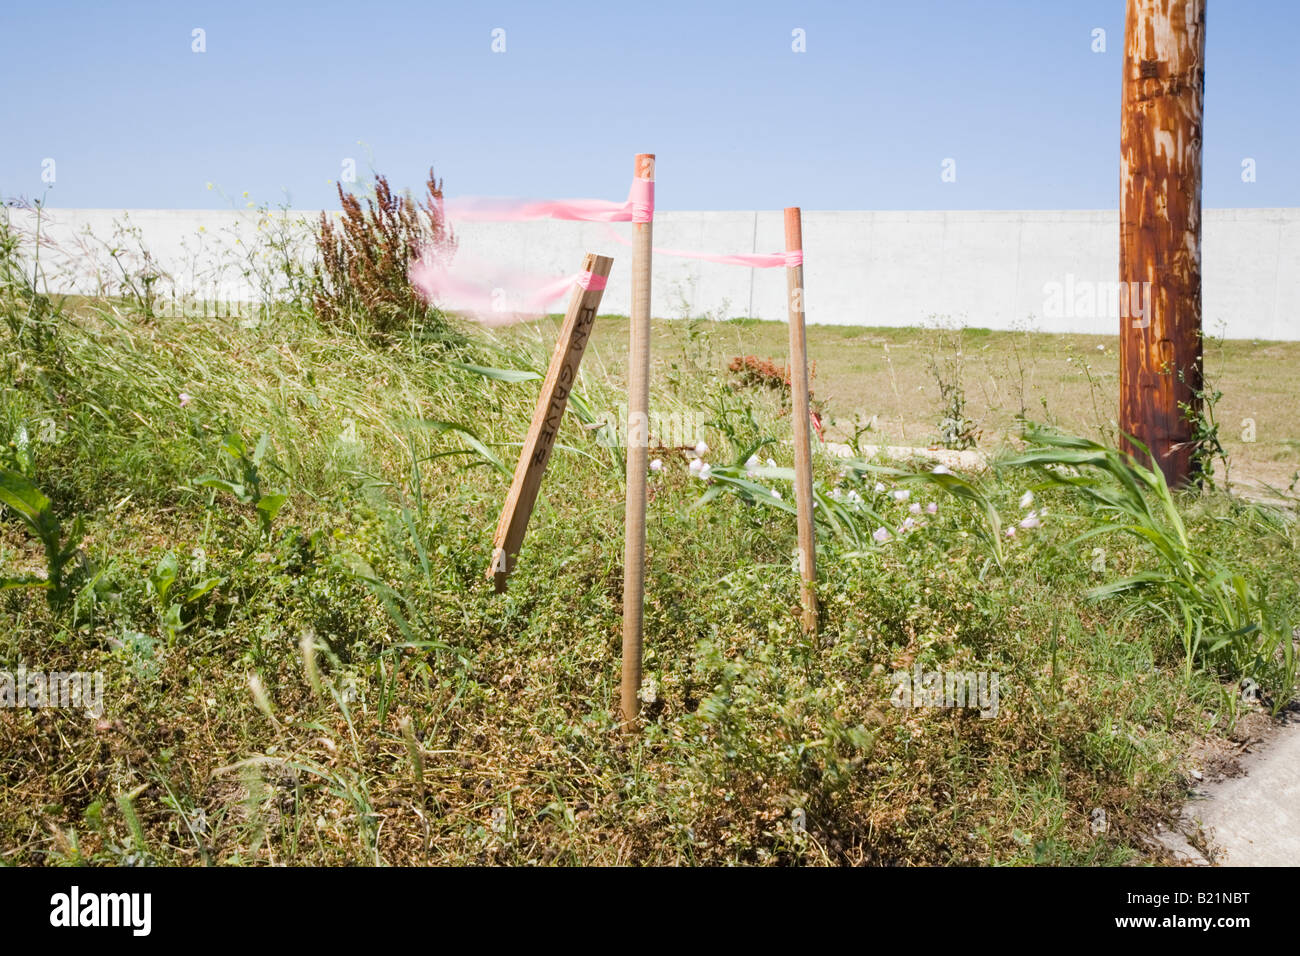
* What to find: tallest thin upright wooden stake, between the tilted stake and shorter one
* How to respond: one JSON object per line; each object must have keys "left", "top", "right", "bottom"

{"left": 620, "top": 152, "right": 654, "bottom": 728}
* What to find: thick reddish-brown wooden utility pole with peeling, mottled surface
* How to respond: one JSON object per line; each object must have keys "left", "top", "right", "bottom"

{"left": 1119, "top": 0, "right": 1205, "bottom": 486}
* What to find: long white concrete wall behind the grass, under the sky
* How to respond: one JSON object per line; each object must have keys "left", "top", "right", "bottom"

{"left": 9, "top": 208, "right": 1300, "bottom": 339}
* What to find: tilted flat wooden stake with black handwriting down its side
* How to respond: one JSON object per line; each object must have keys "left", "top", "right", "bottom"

{"left": 488, "top": 254, "right": 614, "bottom": 594}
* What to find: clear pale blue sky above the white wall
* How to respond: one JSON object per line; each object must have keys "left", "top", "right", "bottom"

{"left": 0, "top": 0, "right": 1300, "bottom": 209}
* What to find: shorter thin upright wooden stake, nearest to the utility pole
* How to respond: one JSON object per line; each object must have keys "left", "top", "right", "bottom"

{"left": 785, "top": 213, "right": 816, "bottom": 635}
